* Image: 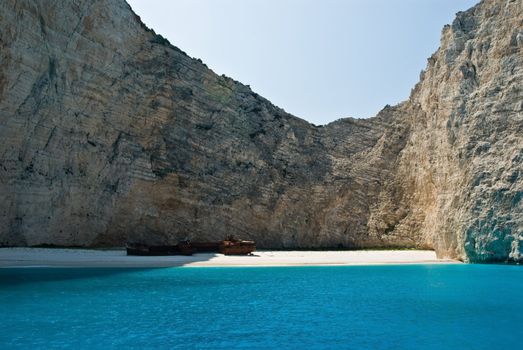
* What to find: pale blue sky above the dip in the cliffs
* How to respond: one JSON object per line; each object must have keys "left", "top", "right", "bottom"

{"left": 128, "top": 0, "right": 477, "bottom": 124}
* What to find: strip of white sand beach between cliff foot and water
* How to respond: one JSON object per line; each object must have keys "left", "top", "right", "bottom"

{"left": 0, "top": 248, "right": 457, "bottom": 267}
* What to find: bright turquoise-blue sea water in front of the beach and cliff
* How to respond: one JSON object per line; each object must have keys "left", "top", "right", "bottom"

{"left": 0, "top": 265, "right": 523, "bottom": 349}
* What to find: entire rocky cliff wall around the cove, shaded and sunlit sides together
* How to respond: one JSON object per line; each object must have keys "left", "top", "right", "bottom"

{"left": 0, "top": 0, "right": 523, "bottom": 261}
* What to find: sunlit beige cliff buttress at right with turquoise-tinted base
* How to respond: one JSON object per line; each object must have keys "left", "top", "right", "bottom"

{"left": 394, "top": 0, "right": 523, "bottom": 261}
